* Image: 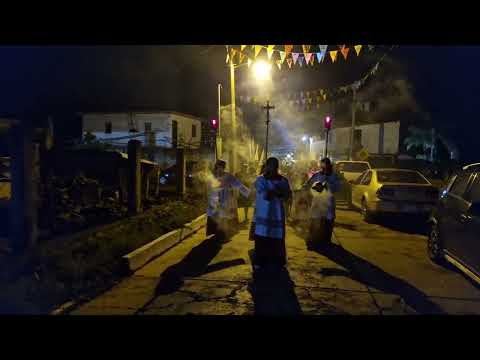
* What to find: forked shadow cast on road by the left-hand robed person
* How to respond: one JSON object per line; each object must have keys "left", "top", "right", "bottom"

{"left": 155, "top": 236, "right": 245, "bottom": 296}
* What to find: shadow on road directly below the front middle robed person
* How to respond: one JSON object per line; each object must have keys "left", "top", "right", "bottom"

{"left": 249, "top": 250, "right": 302, "bottom": 316}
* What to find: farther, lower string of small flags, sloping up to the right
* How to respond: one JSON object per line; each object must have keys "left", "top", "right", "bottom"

{"left": 236, "top": 45, "right": 397, "bottom": 111}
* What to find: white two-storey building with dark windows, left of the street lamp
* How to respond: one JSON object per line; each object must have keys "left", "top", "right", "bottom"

{"left": 81, "top": 112, "right": 202, "bottom": 166}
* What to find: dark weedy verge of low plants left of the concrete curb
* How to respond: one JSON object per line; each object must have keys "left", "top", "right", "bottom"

{"left": 0, "top": 193, "right": 206, "bottom": 314}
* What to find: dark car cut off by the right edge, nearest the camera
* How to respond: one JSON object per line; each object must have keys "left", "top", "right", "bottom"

{"left": 428, "top": 163, "right": 480, "bottom": 283}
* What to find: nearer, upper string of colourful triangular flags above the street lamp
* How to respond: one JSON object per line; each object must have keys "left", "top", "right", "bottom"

{"left": 225, "top": 45, "right": 375, "bottom": 70}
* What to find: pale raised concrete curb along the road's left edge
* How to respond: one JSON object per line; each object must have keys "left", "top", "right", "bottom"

{"left": 50, "top": 215, "right": 207, "bottom": 316}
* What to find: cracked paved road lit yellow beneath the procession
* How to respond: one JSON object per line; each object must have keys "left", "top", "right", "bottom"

{"left": 72, "top": 206, "right": 480, "bottom": 315}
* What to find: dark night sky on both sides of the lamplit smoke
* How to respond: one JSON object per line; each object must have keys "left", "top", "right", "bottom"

{"left": 0, "top": 45, "right": 480, "bottom": 161}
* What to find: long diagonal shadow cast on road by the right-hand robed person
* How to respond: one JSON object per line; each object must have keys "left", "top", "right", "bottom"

{"left": 316, "top": 244, "right": 445, "bottom": 314}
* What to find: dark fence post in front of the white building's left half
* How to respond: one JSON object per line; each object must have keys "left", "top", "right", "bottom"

{"left": 127, "top": 140, "right": 142, "bottom": 215}
